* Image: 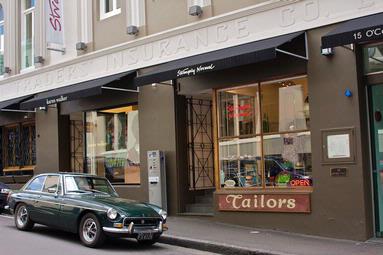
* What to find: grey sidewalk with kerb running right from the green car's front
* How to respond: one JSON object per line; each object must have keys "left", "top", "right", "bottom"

{"left": 161, "top": 217, "right": 383, "bottom": 255}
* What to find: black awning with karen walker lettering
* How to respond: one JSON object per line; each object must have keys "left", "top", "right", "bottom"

{"left": 21, "top": 71, "right": 138, "bottom": 109}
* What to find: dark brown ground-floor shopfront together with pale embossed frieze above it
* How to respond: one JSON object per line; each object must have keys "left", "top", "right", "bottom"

{"left": 0, "top": 1, "right": 383, "bottom": 243}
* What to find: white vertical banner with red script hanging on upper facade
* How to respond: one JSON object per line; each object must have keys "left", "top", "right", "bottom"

{"left": 44, "top": 0, "right": 64, "bottom": 45}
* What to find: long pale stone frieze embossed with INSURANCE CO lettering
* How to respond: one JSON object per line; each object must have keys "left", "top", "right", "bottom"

{"left": 0, "top": 0, "right": 383, "bottom": 101}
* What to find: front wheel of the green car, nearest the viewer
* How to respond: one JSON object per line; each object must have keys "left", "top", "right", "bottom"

{"left": 78, "top": 213, "right": 105, "bottom": 248}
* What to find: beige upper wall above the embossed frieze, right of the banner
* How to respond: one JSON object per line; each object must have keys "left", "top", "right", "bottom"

{"left": 93, "top": 0, "right": 267, "bottom": 50}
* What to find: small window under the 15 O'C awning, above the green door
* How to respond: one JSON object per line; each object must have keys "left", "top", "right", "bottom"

{"left": 363, "top": 44, "right": 383, "bottom": 74}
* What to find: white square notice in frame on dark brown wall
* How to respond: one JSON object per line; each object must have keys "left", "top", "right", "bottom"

{"left": 327, "top": 134, "right": 351, "bottom": 159}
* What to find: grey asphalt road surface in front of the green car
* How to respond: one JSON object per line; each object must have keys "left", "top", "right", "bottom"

{"left": 0, "top": 215, "right": 218, "bottom": 255}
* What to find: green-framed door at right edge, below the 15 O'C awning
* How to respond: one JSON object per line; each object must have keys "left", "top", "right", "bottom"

{"left": 370, "top": 84, "right": 383, "bottom": 237}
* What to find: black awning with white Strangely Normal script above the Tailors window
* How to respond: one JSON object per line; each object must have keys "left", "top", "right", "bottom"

{"left": 135, "top": 32, "right": 307, "bottom": 86}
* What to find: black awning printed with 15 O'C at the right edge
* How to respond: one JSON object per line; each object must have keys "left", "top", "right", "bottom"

{"left": 322, "top": 13, "right": 383, "bottom": 49}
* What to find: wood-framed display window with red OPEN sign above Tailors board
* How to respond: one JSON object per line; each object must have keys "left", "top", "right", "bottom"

{"left": 216, "top": 77, "right": 313, "bottom": 188}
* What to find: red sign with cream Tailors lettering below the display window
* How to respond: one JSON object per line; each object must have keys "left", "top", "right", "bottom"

{"left": 218, "top": 194, "right": 311, "bottom": 213}
